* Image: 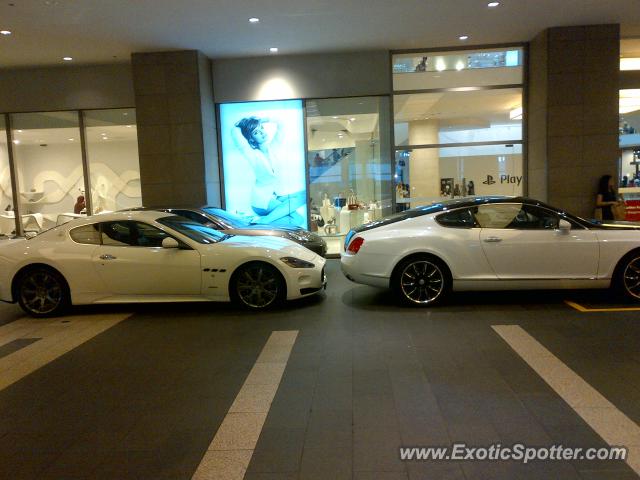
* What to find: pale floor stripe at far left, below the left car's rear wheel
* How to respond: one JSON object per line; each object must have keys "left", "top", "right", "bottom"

{"left": 0, "top": 313, "right": 130, "bottom": 390}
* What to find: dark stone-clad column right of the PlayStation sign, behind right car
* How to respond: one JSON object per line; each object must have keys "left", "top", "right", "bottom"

{"left": 527, "top": 25, "right": 620, "bottom": 217}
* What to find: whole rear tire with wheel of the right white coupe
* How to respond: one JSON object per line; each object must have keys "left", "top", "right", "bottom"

{"left": 391, "top": 255, "right": 451, "bottom": 307}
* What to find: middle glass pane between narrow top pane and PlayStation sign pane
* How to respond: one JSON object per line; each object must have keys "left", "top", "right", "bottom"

{"left": 393, "top": 88, "right": 522, "bottom": 146}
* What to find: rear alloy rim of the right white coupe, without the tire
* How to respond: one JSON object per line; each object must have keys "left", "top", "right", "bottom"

{"left": 400, "top": 260, "right": 445, "bottom": 305}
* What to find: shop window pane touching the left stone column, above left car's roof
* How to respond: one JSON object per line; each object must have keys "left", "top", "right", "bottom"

{"left": 83, "top": 108, "right": 142, "bottom": 213}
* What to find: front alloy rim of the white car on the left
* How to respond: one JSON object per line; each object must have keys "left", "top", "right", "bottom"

{"left": 235, "top": 263, "right": 282, "bottom": 309}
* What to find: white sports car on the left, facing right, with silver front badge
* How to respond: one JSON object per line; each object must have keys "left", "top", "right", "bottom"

{"left": 0, "top": 211, "right": 325, "bottom": 316}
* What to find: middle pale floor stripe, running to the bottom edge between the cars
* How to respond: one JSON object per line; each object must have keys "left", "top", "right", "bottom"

{"left": 192, "top": 330, "right": 298, "bottom": 480}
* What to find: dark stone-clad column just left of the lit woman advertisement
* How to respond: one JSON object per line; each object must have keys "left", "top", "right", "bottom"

{"left": 132, "top": 50, "right": 220, "bottom": 207}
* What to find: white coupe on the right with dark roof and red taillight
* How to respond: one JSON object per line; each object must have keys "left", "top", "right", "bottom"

{"left": 341, "top": 197, "right": 640, "bottom": 306}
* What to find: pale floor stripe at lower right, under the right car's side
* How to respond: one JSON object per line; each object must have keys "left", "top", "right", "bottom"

{"left": 492, "top": 325, "right": 640, "bottom": 475}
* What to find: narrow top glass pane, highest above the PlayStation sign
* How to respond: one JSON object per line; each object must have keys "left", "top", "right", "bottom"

{"left": 392, "top": 47, "right": 524, "bottom": 91}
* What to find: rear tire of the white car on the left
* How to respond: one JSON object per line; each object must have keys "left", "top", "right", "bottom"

{"left": 15, "top": 267, "right": 71, "bottom": 318}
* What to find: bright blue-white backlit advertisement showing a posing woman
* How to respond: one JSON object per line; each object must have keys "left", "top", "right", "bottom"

{"left": 220, "top": 100, "right": 307, "bottom": 228}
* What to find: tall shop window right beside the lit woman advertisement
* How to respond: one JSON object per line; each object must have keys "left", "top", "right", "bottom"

{"left": 306, "top": 97, "right": 392, "bottom": 253}
